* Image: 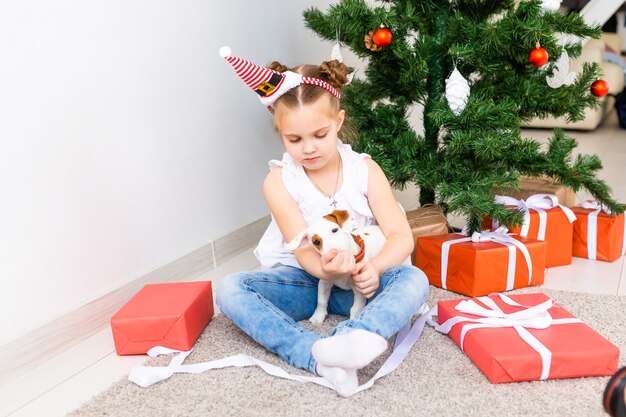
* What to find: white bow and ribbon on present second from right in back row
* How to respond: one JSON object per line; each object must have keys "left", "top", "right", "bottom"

{"left": 495, "top": 194, "right": 576, "bottom": 240}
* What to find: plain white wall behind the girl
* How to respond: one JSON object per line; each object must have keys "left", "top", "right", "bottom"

{"left": 0, "top": 0, "right": 342, "bottom": 345}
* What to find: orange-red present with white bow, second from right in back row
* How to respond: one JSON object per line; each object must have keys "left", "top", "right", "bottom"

{"left": 495, "top": 194, "right": 576, "bottom": 268}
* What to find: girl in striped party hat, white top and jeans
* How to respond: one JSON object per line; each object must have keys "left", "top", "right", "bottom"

{"left": 216, "top": 50, "right": 429, "bottom": 396}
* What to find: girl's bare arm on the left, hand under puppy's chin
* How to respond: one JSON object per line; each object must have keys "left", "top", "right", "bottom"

{"left": 263, "top": 167, "right": 355, "bottom": 280}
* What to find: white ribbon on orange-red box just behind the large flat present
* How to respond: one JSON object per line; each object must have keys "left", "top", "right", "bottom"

{"left": 441, "top": 226, "right": 533, "bottom": 291}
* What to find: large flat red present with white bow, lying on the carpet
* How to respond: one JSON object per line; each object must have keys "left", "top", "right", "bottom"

{"left": 435, "top": 293, "right": 619, "bottom": 383}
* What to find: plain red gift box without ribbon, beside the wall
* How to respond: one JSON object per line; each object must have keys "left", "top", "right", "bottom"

{"left": 111, "top": 281, "right": 213, "bottom": 355}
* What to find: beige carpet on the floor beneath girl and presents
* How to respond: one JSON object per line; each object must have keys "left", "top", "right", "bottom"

{"left": 70, "top": 287, "right": 626, "bottom": 417}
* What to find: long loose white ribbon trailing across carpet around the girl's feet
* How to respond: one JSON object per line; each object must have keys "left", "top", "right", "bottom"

{"left": 128, "top": 304, "right": 429, "bottom": 394}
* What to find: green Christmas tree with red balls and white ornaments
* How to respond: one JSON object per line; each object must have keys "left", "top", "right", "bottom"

{"left": 304, "top": 0, "right": 623, "bottom": 233}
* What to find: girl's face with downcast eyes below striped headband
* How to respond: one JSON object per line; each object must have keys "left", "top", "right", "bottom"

{"left": 274, "top": 94, "right": 345, "bottom": 170}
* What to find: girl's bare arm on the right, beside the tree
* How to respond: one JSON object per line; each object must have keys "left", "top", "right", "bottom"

{"left": 358, "top": 158, "right": 414, "bottom": 276}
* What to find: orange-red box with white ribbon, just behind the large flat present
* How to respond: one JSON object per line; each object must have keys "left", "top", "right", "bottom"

{"left": 415, "top": 231, "right": 547, "bottom": 297}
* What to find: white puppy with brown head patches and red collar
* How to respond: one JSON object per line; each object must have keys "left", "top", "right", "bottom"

{"left": 285, "top": 210, "right": 411, "bottom": 324}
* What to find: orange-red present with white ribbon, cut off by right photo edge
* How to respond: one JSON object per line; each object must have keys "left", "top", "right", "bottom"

{"left": 572, "top": 201, "right": 626, "bottom": 262}
